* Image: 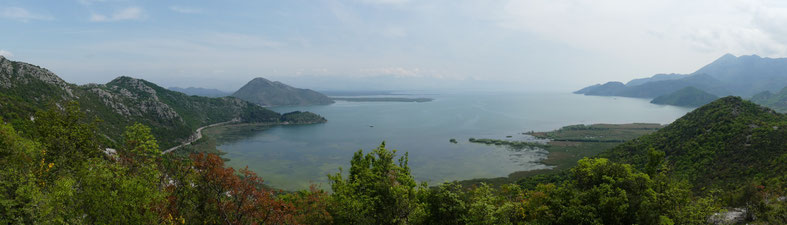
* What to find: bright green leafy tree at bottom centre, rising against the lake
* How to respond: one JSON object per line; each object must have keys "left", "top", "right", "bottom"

{"left": 328, "top": 142, "right": 423, "bottom": 224}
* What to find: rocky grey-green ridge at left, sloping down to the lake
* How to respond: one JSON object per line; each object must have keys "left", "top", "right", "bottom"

{"left": 0, "top": 56, "right": 318, "bottom": 148}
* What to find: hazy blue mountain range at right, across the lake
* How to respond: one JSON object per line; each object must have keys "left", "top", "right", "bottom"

{"left": 574, "top": 54, "right": 787, "bottom": 105}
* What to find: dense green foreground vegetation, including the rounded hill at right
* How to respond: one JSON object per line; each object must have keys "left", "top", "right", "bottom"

{"left": 0, "top": 97, "right": 787, "bottom": 224}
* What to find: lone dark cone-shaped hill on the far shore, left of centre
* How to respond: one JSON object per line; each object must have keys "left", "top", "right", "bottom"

{"left": 232, "top": 77, "right": 333, "bottom": 106}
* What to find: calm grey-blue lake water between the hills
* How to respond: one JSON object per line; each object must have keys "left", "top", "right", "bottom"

{"left": 212, "top": 93, "right": 692, "bottom": 190}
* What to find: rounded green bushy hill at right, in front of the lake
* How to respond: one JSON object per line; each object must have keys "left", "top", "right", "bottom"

{"left": 600, "top": 97, "right": 787, "bottom": 191}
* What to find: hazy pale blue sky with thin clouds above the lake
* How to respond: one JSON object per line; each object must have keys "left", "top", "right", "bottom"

{"left": 0, "top": 0, "right": 787, "bottom": 91}
